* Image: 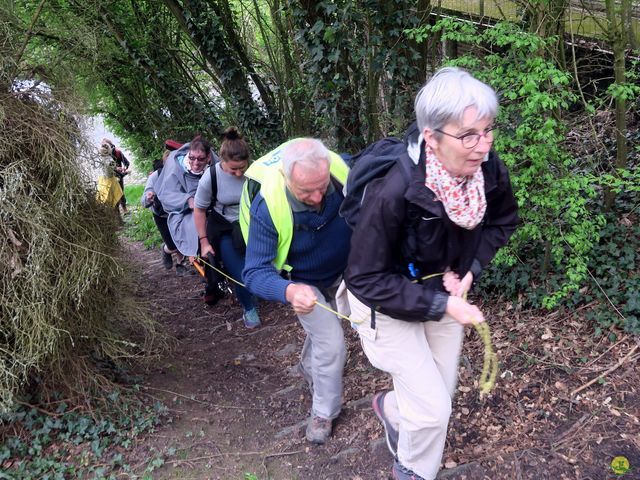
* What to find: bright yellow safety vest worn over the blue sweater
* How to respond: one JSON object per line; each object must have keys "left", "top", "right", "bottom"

{"left": 240, "top": 140, "right": 349, "bottom": 271}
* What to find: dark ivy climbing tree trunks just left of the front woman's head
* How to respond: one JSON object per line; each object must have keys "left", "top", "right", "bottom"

{"left": 290, "top": 0, "right": 426, "bottom": 152}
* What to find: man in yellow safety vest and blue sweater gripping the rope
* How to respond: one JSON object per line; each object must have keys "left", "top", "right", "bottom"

{"left": 240, "top": 138, "right": 351, "bottom": 444}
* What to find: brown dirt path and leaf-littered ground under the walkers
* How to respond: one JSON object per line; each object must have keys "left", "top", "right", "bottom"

{"left": 112, "top": 243, "right": 640, "bottom": 480}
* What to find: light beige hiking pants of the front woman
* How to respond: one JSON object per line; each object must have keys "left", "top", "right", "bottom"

{"left": 349, "top": 293, "right": 464, "bottom": 480}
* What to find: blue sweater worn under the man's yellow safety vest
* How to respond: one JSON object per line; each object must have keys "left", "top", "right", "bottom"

{"left": 242, "top": 190, "right": 351, "bottom": 303}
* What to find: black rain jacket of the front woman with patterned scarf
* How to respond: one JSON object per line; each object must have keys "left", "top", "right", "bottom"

{"left": 344, "top": 124, "right": 519, "bottom": 321}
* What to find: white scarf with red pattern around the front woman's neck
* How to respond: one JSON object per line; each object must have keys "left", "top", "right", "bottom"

{"left": 425, "top": 145, "right": 487, "bottom": 230}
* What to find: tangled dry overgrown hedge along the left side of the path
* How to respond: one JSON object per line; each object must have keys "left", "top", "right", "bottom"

{"left": 0, "top": 92, "right": 159, "bottom": 411}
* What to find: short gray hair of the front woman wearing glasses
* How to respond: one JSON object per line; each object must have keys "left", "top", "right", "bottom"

{"left": 415, "top": 67, "right": 498, "bottom": 132}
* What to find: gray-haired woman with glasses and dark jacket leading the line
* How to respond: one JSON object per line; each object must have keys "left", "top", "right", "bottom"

{"left": 345, "top": 68, "right": 518, "bottom": 480}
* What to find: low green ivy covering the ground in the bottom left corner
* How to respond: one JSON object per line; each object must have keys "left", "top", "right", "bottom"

{"left": 0, "top": 391, "right": 172, "bottom": 480}
